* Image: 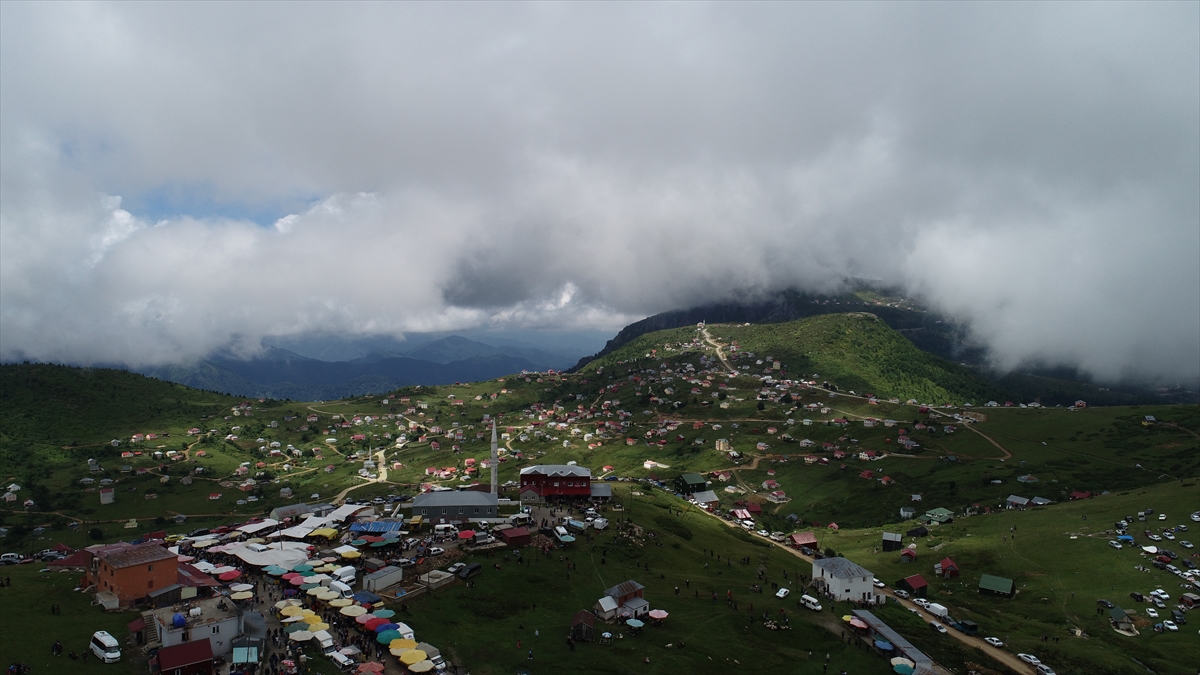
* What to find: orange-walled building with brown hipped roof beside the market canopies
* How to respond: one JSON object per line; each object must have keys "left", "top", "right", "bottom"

{"left": 88, "top": 542, "right": 179, "bottom": 607}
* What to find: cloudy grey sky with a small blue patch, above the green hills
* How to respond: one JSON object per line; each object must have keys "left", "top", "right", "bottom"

{"left": 0, "top": 1, "right": 1200, "bottom": 381}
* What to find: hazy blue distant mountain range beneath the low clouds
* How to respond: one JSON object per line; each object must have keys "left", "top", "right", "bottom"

{"left": 138, "top": 335, "right": 574, "bottom": 401}
